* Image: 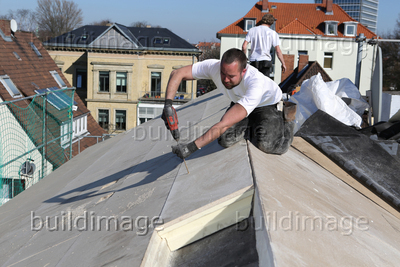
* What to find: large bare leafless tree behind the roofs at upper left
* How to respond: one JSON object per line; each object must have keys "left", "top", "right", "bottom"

{"left": 36, "top": 0, "right": 83, "bottom": 39}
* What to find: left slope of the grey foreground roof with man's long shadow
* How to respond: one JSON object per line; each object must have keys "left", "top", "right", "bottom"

{"left": 0, "top": 92, "right": 245, "bottom": 266}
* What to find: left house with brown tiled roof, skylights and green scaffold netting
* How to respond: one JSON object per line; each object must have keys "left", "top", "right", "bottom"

{"left": 0, "top": 20, "right": 106, "bottom": 205}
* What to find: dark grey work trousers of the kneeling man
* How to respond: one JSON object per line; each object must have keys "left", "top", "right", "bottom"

{"left": 218, "top": 103, "right": 294, "bottom": 155}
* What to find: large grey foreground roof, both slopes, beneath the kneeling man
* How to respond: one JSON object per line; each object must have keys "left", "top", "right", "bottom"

{"left": 0, "top": 91, "right": 400, "bottom": 266}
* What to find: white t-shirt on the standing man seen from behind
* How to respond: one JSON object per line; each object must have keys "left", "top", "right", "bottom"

{"left": 245, "top": 25, "right": 279, "bottom": 61}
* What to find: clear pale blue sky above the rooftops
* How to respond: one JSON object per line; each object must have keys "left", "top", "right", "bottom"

{"left": 0, "top": 0, "right": 400, "bottom": 44}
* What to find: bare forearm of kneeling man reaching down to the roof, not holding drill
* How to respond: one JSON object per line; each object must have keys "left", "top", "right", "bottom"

{"left": 195, "top": 103, "right": 247, "bottom": 148}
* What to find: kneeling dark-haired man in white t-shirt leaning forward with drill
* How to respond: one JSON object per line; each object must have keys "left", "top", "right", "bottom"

{"left": 162, "top": 48, "right": 294, "bottom": 158}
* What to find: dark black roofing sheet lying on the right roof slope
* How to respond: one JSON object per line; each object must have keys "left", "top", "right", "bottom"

{"left": 296, "top": 110, "right": 400, "bottom": 210}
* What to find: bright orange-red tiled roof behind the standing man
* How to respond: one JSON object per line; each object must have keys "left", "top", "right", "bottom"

{"left": 217, "top": 1, "right": 376, "bottom": 38}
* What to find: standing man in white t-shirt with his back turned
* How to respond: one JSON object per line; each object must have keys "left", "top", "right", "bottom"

{"left": 242, "top": 13, "right": 286, "bottom": 77}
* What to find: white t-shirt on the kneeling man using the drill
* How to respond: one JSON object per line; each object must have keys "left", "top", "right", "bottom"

{"left": 192, "top": 59, "right": 282, "bottom": 116}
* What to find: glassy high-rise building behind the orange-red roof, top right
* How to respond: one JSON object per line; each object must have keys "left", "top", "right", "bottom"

{"left": 315, "top": 0, "right": 379, "bottom": 33}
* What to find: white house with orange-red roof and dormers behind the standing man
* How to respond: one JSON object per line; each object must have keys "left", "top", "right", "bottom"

{"left": 217, "top": 0, "right": 375, "bottom": 95}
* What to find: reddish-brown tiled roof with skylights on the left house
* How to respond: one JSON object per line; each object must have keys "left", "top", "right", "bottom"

{"left": 0, "top": 20, "right": 106, "bottom": 161}
